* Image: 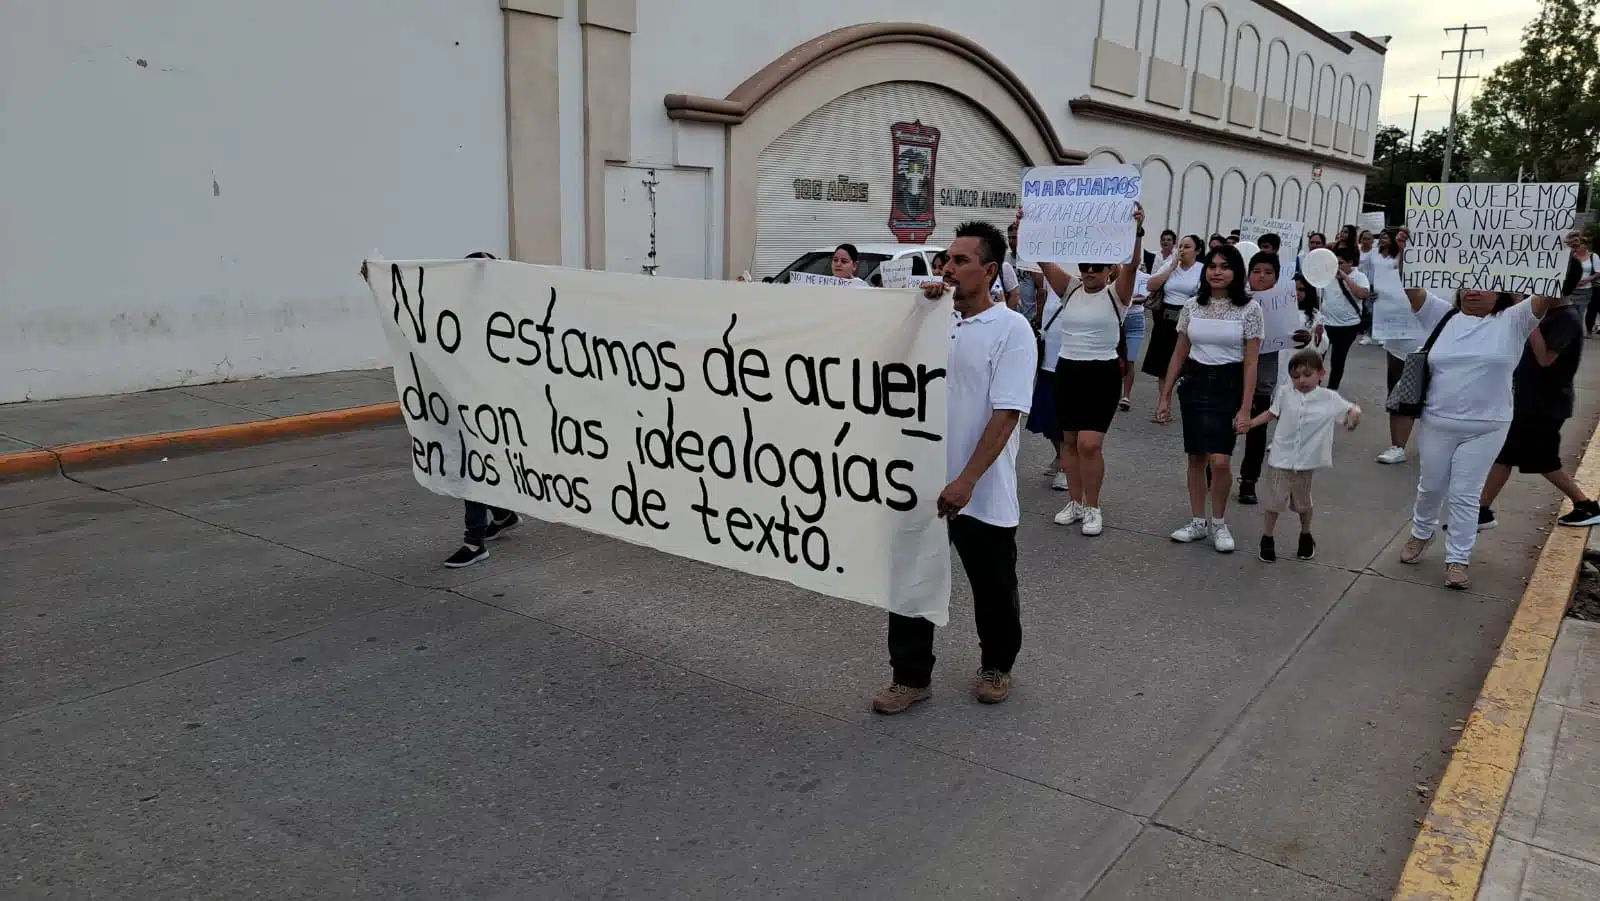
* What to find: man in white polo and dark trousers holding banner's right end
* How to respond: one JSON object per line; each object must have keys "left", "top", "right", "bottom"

{"left": 872, "top": 221, "right": 1038, "bottom": 714}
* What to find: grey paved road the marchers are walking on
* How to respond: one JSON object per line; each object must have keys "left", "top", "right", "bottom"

{"left": 0, "top": 349, "right": 1600, "bottom": 901}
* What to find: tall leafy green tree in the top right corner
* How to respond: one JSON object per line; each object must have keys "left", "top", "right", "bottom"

{"left": 1451, "top": 0, "right": 1600, "bottom": 182}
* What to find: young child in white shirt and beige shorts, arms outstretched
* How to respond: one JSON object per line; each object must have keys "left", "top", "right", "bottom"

{"left": 1242, "top": 347, "right": 1362, "bottom": 563}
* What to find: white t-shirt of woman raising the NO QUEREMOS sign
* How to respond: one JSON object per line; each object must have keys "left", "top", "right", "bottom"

{"left": 1416, "top": 294, "right": 1539, "bottom": 422}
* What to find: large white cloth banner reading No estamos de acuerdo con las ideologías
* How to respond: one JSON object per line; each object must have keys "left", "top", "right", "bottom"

{"left": 370, "top": 259, "right": 950, "bottom": 624}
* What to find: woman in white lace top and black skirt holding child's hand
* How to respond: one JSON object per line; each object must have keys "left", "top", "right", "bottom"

{"left": 1155, "top": 245, "right": 1266, "bottom": 554}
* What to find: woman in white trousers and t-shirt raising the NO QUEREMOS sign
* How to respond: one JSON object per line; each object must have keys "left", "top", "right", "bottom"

{"left": 1400, "top": 288, "right": 1550, "bottom": 589}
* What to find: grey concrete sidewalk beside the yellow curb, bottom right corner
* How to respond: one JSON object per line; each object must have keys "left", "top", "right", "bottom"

{"left": 1478, "top": 619, "right": 1600, "bottom": 901}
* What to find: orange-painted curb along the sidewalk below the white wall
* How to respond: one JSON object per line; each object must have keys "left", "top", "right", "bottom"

{"left": 0, "top": 402, "right": 400, "bottom": 479}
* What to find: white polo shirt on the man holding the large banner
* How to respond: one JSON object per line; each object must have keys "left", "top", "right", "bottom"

{"left": 944, "top": 304, "right": 1038, "bottom": 528}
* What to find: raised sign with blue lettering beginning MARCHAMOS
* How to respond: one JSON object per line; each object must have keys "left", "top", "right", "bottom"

{"left": 1016, "top": 166, "right": 1144, "bottom": 269}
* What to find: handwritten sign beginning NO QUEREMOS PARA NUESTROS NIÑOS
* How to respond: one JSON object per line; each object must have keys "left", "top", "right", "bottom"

{"left": 1402, "top": 182, "right": 1578, "bottom": 296}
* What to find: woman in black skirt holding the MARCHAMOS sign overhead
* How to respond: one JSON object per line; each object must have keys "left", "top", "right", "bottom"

{"left": 1038, "top": 203, "right": 1144, "bottom": 536}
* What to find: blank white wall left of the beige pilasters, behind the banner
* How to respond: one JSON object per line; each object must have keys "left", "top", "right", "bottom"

{"left": 0, "top": 0, "right": 505, "bottom": 402}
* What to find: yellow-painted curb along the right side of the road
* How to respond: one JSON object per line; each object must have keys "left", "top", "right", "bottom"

{"left": 1394, "top": 416, "right": 1600, "bottom": 901}
